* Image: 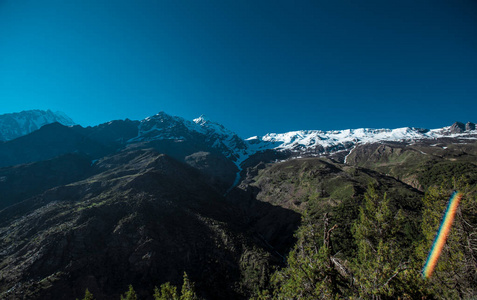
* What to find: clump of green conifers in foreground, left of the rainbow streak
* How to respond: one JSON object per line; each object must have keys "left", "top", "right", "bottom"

{"left": 262, "top": 185, "right": 431, "bottom": 299}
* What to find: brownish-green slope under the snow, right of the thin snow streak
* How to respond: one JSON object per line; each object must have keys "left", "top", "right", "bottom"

{"left": 346, "top": 138, "right": 477, "bottom": 190}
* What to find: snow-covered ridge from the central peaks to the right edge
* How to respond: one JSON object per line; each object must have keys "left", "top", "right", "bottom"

{"left": 128, "top": 112, "right": 477, "bottom": 188}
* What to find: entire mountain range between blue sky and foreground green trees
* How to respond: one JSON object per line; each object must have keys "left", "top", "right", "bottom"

{"left": 0, "top": 111, "right": 477, "bottom": 299}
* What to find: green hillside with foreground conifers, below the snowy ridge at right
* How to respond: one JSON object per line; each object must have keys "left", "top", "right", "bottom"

{"left": 242, "top": 143, "right": 477, "bottom": 299}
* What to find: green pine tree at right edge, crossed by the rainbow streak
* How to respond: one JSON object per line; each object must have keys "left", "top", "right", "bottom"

{"left": 416, "top": 178, "right": 477, "bottom": 299}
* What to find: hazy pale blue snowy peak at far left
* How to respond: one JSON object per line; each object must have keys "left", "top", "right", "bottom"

{"left": 0, "top": 110, "right": 75, "bottom": 141}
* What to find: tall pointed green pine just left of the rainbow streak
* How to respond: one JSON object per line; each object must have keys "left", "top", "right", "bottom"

{"left": 352, "top": 185, "right": 425, "bottom": 299}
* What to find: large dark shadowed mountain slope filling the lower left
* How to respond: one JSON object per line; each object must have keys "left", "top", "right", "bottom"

{"left": 0, "top": 150, "right": 298, "bottom": 299}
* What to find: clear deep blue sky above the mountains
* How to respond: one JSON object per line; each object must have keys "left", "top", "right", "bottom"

{"left": 0, "top": 0, "right": 477, "bottom": 137}
